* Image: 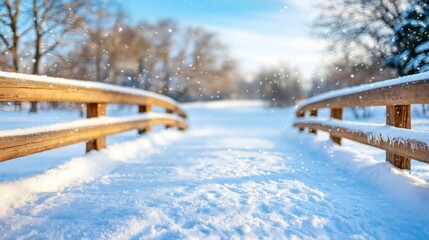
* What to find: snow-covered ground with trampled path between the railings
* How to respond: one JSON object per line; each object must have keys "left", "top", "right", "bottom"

{"left": 0, "top": 102, "right": 429, "bottom": 239}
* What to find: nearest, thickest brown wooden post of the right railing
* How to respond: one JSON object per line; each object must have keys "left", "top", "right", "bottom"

{"left": 386, "top": 105, "right": 411, "bottom": 170}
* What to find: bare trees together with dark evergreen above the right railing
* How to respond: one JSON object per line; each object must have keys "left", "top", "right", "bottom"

{"left": 309, "top": 0, "right": 429, "bottom": 116}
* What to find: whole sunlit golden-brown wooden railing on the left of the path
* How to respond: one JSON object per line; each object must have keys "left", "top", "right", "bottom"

{"left": 0, "top": 72, "right": 187, "bottom": 162}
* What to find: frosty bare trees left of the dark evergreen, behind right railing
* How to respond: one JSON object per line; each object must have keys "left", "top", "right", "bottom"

{"left": 309, "top": 0, "right": 412, "bottom": 95}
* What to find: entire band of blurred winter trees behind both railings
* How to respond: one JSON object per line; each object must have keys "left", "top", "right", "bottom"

{"left": 0, "top": 0, "right": 429, "bottom": 111}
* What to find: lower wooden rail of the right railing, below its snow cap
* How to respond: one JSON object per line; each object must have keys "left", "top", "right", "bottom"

{"left": 294, "top": 123, "right": 429, "bottom": 163}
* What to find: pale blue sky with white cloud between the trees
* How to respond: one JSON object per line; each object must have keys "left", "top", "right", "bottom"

{"left": 121, "top": 0, "right": 323, "bottom": 79}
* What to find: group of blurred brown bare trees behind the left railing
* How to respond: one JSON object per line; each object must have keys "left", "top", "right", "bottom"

{"left": 0, "top": 0, "right": 241, "bottom": 112}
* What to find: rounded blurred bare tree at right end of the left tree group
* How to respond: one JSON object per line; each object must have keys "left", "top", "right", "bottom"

{"left": 175, "top": 27, "right": 236, "bottom": 101}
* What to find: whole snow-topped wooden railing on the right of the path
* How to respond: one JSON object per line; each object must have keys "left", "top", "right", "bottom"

{"left": 294, "top": 73, "right": 429, "bottom": 169}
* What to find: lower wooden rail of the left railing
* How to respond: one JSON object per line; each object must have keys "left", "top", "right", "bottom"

{"left": 0, "top": 117, "right": 187, "bottom": 162}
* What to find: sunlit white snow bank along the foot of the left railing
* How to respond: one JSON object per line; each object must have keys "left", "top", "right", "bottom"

{"left": 0, "top": 131, "right": 181, "bottom": 218}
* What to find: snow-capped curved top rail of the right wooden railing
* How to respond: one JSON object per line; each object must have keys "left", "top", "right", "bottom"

{"left": 297, "top": 72, "right": 429, "bottom": 114}
